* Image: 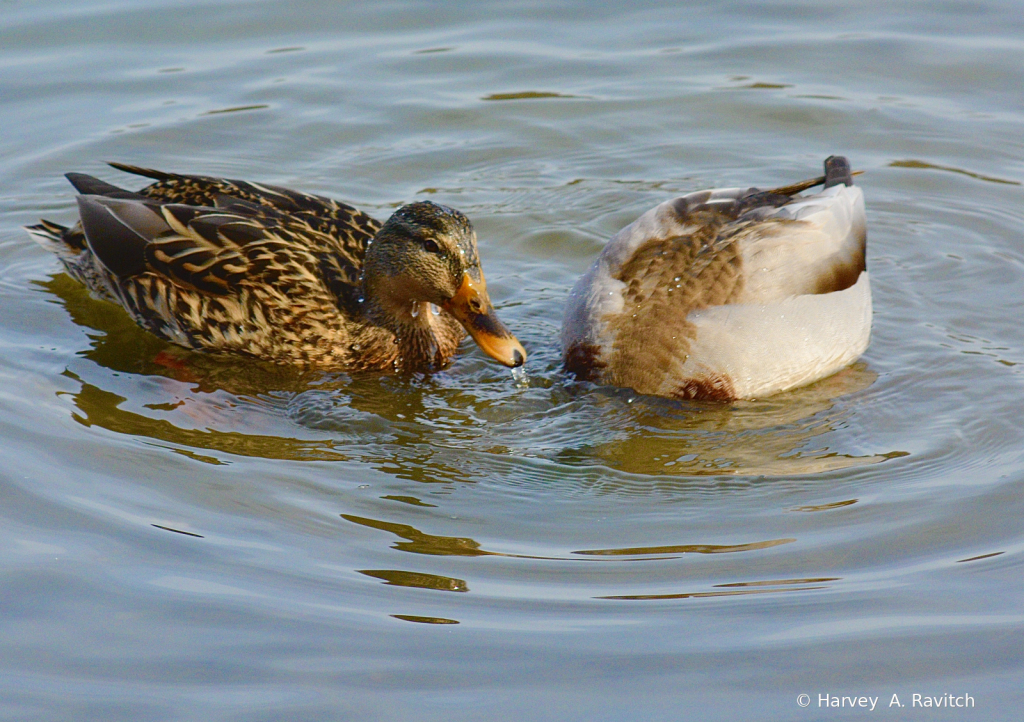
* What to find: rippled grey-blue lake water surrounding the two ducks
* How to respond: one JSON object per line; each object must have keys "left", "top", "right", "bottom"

{"left": 0, "top": 0, "right": 1024, "bottom": 722}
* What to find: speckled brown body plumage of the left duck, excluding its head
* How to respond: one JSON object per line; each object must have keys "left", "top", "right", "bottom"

{"left": 30, "top": 163, "right": 483, "bottom": 370}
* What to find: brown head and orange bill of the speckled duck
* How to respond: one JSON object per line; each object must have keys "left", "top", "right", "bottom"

{"left": 364, "top": 201, "right": 526, "bottom": 368}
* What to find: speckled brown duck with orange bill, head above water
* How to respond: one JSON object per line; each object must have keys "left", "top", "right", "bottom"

{"left": 29, "top": 163, "right": 526, "bottom": 371}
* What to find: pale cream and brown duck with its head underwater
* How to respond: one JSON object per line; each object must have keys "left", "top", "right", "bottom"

{"left": 562, "top": 156, "right": 871, "bottom": 400}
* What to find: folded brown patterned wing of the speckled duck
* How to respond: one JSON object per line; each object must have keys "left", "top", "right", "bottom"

{"left": 71, "top": 190, "right": 356, "bottom": 355}
